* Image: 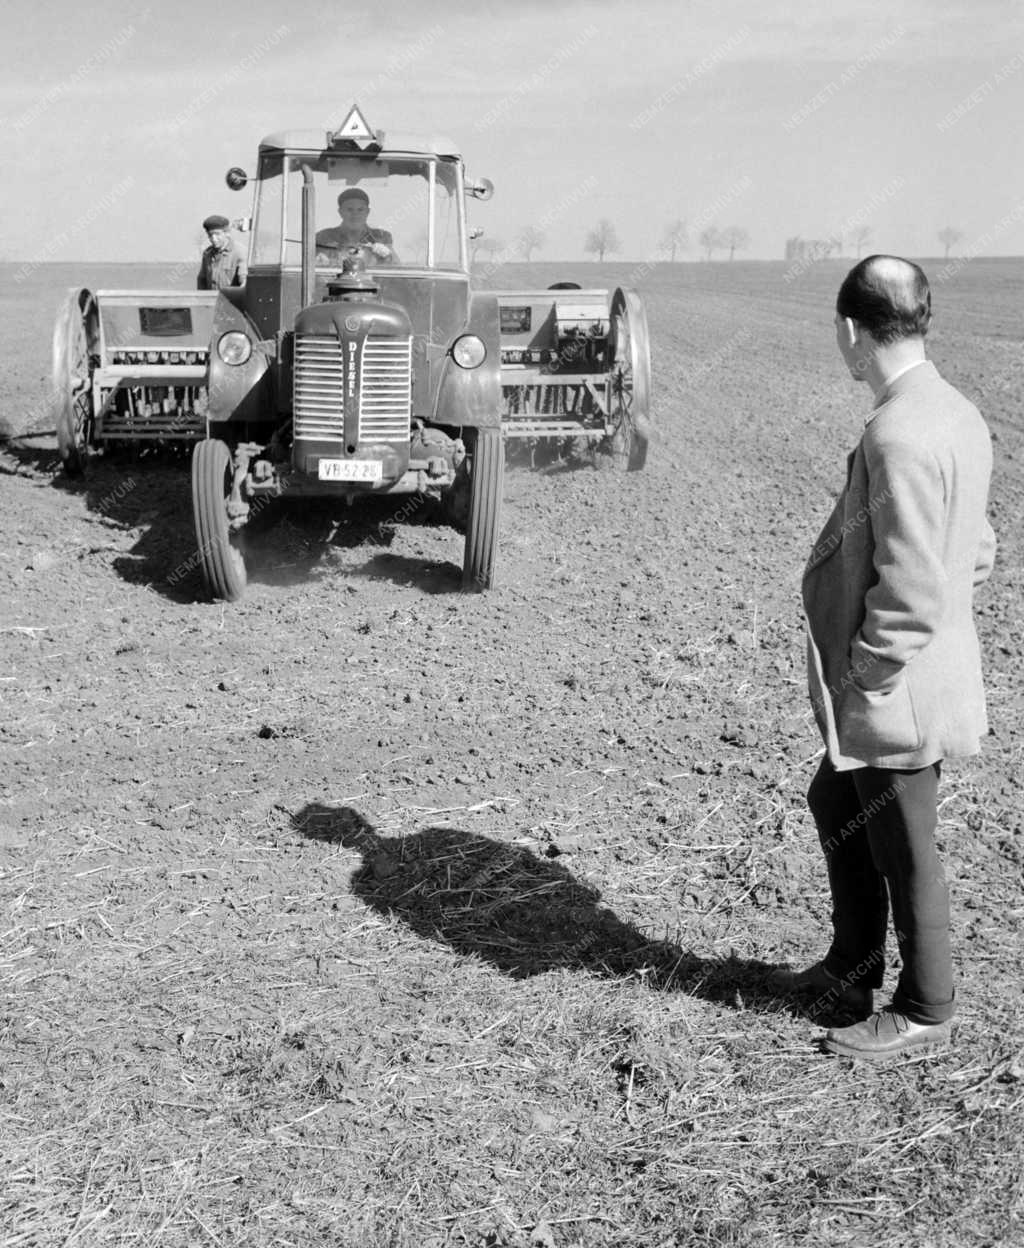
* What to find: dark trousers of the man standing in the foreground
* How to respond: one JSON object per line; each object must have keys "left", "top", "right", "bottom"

{"left": 807, "top": 758, "right": 954, "bottom": 1023}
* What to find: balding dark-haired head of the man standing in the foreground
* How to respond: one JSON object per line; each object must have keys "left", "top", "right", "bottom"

{"left": 836, "top": 256, "right": 932, "bottom": 344}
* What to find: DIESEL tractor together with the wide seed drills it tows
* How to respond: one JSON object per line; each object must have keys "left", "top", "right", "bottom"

{"left": 54, "top": 106, "right": 650, "bottom": 602}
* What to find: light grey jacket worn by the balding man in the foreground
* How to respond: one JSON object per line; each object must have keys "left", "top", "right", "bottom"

{"left": 803, "top": 361, "right": 995, "bottom": 771}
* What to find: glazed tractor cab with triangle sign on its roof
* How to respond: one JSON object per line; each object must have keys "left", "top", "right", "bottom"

{"left": 235, "top": 107, "right": 493, "bottom": 346}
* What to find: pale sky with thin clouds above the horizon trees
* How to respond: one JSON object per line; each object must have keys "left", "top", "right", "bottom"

{"left": 0, "top": 0, "right": 1024, "bottom": 262}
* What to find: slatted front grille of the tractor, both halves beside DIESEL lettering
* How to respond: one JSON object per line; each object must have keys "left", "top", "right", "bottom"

{"left": 293, "top": 333, "right": 413, "bottom": 443}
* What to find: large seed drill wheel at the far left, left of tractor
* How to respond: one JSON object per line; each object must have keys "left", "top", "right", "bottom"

{"left": 52, "top": 286, "right": 100, "bottom": 475}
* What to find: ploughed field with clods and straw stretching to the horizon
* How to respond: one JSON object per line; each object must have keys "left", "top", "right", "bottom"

{"left": 0, "top": 260, "right": 1024, "bottom": 1248}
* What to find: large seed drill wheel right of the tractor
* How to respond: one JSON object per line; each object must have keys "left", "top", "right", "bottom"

{"left": 607, "top": 288, "right": 651, "bottom": 472}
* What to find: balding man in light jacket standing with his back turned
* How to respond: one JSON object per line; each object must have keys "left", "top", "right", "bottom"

{"left": 775, "top": 256, "right": 995, "bottom": 1061}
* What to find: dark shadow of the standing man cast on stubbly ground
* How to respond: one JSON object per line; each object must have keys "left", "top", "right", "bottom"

{"left": 292, "top": 802, "right": 801, "bottom": 1012}
